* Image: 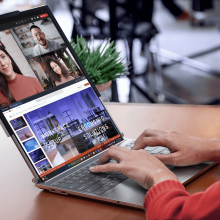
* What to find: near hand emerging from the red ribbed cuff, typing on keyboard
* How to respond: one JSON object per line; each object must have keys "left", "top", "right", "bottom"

{"left": 90, "top": 145, "right": 178, "bottom": 189}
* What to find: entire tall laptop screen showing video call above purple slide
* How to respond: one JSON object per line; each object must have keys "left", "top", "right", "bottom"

{"left": 0, "top": 7, "right": 122, "bottom": 181}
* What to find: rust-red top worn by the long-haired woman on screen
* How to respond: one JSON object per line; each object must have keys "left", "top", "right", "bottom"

{"left": 0, "top": 74, "right": 44, "bottom": 105}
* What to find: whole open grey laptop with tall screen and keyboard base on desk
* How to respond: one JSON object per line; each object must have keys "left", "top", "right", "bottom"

{"left": 0, "top": 6, "right": 214, "bottom": 209}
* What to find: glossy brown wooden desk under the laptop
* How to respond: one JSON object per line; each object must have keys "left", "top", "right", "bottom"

{"left": 0, "top": 103, "right": 220, "bottom": 220}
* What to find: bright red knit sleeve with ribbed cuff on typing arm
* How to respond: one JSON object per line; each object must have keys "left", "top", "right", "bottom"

{"left": 144, "top": 180, "right": 220, "bottom": 220}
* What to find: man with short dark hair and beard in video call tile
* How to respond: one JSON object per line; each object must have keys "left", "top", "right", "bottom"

{"left": 30, "top": 25, "right": 61, "bottom": 56}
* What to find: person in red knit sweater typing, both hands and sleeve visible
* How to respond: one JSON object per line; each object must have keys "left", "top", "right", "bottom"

{"left": 90, "top": 129, "right": 220, "bottom": 220}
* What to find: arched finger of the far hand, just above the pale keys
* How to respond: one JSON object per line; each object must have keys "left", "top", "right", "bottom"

{"left": 132, "top": 136, "right": 169, "bottom": 150}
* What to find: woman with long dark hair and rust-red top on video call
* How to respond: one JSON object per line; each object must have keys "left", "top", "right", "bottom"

{"left": 0, "top": 46, "right": 44, "bottom": 106}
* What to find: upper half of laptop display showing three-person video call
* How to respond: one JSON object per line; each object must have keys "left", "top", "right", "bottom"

{"left": 0, "top": 13, "right": 83, "bottom": 107}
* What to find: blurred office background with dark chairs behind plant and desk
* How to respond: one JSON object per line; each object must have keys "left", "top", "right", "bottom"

{"left": 0, "top": 0, "right": 220, "bottom": 105}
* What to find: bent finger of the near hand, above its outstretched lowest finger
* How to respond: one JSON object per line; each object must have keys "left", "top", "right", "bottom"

{"left": 98, "top": 145, "right": 127, "bottom": 165}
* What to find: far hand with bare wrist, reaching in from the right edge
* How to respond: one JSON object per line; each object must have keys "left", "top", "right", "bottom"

{"left": 132, "top": 129, "right": 220, "bottom": 166}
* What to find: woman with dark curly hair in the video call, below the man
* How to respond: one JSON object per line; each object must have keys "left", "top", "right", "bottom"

{"left": 44, "top": 56, "right": 74, "bottom": 86}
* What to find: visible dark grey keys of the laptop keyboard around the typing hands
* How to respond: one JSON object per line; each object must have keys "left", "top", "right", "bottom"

{"left": 51, "top": 141, "right": 170, "bottom": 195}
